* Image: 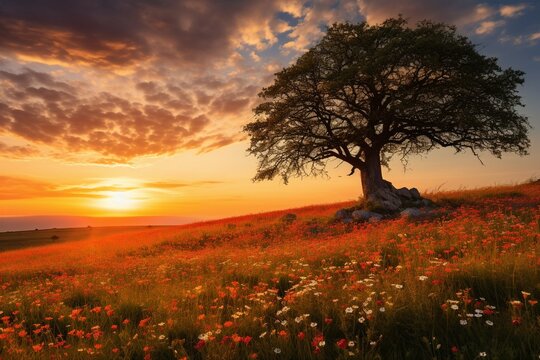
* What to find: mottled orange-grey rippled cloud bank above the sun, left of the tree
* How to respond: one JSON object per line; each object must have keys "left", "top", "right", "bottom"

{"left": 0, "top": 70, "right": 249, "bottom": 164}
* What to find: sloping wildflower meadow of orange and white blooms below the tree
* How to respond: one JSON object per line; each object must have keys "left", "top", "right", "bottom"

{"left": 0, "top": 182, "right": 540, "bottom": 360}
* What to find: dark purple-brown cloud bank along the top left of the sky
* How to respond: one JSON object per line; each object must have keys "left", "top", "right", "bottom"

{"left": 0, "top": 0, "right": 286, "bottom": 67}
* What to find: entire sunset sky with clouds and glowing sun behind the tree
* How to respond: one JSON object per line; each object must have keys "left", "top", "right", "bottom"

{"left": 0, "top": 0, "right": 540, "bottom": 224}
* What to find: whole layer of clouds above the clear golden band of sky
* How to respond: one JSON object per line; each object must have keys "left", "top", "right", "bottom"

{"left": 0, "top": 0, "right": 536, "bottom": 164}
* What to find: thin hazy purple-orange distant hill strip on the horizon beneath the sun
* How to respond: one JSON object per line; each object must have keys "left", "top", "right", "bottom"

{"left": 0, "top": 215, "right": 199, "bottom": 232}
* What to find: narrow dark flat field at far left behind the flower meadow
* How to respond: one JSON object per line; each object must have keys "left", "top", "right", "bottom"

{"left": 0, "top": 226, "right": 169, "bottom": 252}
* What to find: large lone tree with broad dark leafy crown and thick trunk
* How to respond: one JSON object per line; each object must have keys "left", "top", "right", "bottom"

{"left": 244, "top": 17, "right": 530, "bottom": 210}
